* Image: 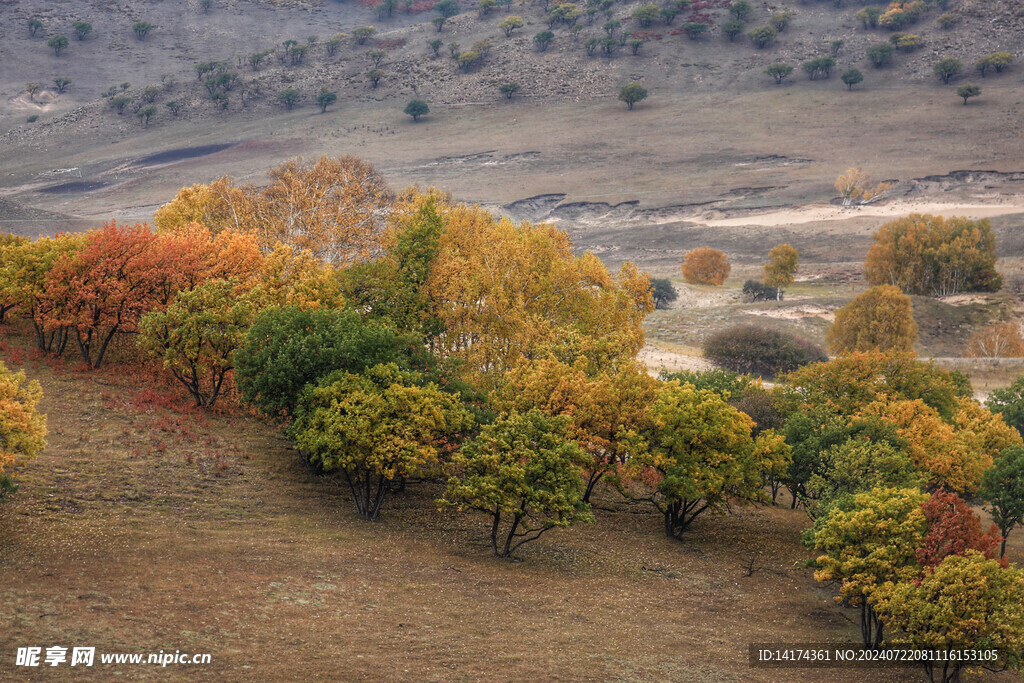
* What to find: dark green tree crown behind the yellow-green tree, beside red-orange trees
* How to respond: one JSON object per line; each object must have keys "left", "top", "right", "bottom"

{"left": 234, "top": 306, "right": 416, "bottom": 416}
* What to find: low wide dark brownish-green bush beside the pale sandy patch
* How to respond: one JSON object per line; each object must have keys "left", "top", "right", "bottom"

{"left": 705, "top": 326, "right": 828, "bottom": 377}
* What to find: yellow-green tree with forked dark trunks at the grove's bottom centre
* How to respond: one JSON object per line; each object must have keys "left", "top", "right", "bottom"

{"left": 438, "top": 410, "right": 594, "bottom": 558}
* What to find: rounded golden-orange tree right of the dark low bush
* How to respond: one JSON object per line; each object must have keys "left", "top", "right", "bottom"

{"left": 827, "top": 285, "right": 918, "bottom": 354}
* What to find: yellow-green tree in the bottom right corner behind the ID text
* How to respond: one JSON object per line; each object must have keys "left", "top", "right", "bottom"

{"left": 872, "top": 551, "right": 1024, "bottom": 683}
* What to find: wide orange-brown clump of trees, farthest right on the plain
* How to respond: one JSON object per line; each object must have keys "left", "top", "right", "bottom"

{"left": 864, "top": 213, "right": 1002, "bottom": 296}
